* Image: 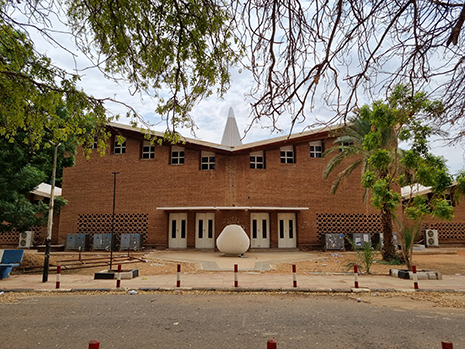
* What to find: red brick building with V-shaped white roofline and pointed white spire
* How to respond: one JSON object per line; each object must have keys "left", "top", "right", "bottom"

{"left": 53, "top": 110, "right": 465, "bottom": 249}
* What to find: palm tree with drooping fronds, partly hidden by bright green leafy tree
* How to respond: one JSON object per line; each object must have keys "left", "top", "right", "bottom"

{"left": 323, "top": 116, "right": 396, "bottom": 260}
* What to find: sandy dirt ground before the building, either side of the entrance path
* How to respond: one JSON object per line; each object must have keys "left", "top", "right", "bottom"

{"left": 15, "top": 250, "right": 465, "bottom": 275}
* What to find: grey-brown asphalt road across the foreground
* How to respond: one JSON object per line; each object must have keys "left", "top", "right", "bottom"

{"left": 0, "top": 294, "right": 465, "bottom": 349}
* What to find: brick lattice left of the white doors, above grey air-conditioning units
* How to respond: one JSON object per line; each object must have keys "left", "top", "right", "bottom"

{"left": 77, "top": 213, "right": 149, "bottom": 244}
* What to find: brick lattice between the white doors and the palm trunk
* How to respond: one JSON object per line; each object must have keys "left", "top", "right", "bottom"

{"left": 316, "top": 213, "right": 382, "bottom": 243}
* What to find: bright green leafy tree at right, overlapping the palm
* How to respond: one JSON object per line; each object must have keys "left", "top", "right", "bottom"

{"left": 360, "top": 85, "right": 453, "bottom": 267}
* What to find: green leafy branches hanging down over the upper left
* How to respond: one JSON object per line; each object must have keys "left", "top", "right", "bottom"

{"left": 0, "top": 0, "right": 241, "bottom": 138}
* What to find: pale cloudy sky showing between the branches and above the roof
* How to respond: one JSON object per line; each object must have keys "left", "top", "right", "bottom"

{"left": 18, "top": 8, "right": 464, "bottom": 173}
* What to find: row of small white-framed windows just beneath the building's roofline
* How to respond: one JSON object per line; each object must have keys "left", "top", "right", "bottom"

{"left": 108, "top": 140, "right": 323, "bottom": 170}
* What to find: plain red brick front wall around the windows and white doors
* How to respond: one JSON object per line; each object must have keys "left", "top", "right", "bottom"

{"left": 59, "top": 128, "right": 454, "bottom": 247}
